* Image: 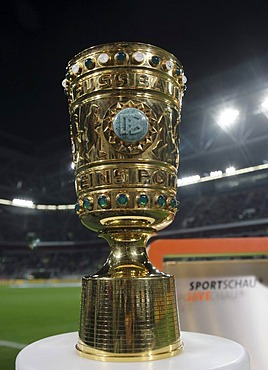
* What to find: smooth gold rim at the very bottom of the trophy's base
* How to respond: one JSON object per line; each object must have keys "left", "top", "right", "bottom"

{"left": 76, "top": 339, "right": 183, "bottom": 362}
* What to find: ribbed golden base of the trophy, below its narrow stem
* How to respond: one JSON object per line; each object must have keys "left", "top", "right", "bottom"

{"left": 76, "top": 272, "right": 183, "bottom": 361}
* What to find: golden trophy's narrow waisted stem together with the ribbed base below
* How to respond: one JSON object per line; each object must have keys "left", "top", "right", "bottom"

{"left": 76, "top": 229, "right": 183, "bottom": 361}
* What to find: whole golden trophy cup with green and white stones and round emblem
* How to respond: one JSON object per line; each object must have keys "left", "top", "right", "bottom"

{"left": 63, "top": 42, "right": 186, "bottom": 361}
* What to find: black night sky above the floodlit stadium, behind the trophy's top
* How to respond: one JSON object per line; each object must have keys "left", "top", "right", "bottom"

{"left": 0, "top": 0, "right": 268, "bottom": 144}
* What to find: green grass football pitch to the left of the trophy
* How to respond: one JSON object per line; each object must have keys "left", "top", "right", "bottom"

{"left": 0, "top": 284, "right": 80, "bottom": 370}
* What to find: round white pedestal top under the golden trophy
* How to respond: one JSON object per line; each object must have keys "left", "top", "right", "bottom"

{"left": 16, "top": 332, "right": 250, "bottom": 370}
